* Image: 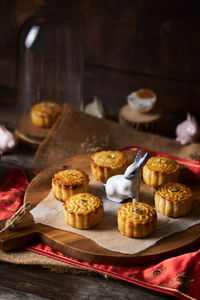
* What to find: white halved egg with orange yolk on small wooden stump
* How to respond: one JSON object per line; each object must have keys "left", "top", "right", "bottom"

{"left": 127, "top": 89, "right": 157, "bottom": 113}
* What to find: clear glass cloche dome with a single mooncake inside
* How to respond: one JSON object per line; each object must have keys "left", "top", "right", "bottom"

{"left": 16, "top": 12, "right": 84, "bottom": 145}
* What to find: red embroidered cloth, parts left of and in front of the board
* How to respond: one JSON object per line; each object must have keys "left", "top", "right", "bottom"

{"left": 0, "top": 169, "right": 200, "bottom": 300}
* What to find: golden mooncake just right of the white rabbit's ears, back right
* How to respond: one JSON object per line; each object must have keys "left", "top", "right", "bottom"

{"left": 142, "top": 156, "right": 180, "bottom": 188}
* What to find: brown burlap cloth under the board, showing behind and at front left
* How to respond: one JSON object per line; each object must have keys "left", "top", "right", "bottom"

{"left": 0, "top": 106, "right": 200, "bottom": 272}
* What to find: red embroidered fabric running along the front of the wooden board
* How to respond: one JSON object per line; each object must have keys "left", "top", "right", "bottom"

{"left": 26, "top": 243, "right": 200, "bottom": 300}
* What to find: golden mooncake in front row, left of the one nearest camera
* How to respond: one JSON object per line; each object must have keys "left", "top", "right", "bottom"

{"left": 64, "top": 193, "right": 104, "bottom": 229}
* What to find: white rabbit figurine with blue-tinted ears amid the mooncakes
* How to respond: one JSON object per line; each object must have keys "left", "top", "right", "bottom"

{"left": 104, "top": 150, "right": 148, "bottom": 203}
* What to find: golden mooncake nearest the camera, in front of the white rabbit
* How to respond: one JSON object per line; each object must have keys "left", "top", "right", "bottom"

{"left": 117, "top": 202, "right": 157, "bottom": 238}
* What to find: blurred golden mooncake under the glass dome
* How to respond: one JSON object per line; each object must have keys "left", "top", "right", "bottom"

{"left": 31, "top": 102, "right": 62, "bottom": 128}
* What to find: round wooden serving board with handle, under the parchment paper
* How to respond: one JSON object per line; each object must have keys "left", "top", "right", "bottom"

{"left": 0, "top": 151, "right": 200, "bottom": 265}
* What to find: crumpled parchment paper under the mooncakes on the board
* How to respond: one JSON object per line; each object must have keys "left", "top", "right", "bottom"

{"left": 31, "top": 182, "right": 200, "bottom": 254}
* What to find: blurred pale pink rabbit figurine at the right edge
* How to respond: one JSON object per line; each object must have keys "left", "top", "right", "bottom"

{"left": 176, "top": 113, "right": 199, "bottom": 145}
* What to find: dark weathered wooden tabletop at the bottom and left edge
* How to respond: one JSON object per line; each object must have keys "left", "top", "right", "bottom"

{"left": 0, "top": 138, "right": 178, "bottom": 300}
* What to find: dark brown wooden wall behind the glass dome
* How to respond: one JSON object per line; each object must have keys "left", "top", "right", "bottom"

{"left": 0, "top": 0, "right": 200, "bottom": 137}
